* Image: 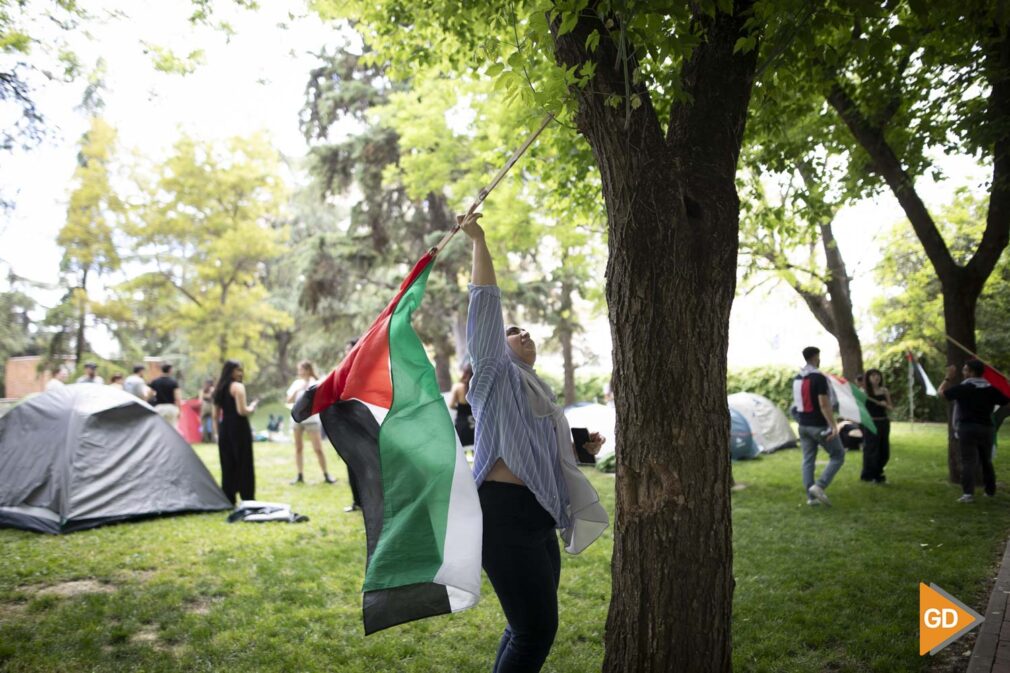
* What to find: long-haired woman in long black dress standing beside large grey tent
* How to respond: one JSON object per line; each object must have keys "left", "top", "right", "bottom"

{"left": 214, "top": 360, "right": 257, "bottom": 504}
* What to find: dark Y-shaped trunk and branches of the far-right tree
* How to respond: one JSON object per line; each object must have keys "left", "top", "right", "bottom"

{"left": 827, "top": 20, "right": 1010, "bottom": 482}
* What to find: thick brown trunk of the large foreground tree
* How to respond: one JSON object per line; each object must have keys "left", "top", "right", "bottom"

{"left": 556, "top": 2, "right": 755, "bottom": 673}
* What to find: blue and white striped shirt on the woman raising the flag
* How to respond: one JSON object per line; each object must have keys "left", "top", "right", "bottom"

{"left": 467, "top": 285, "right": 571, "bottom": 528}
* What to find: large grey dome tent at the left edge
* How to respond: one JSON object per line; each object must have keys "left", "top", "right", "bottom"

{"left": 0, "top": 383, "right": 231, "bottom": 534}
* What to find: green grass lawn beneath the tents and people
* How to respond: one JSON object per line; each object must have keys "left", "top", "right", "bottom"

{"left": 0, "top": 423, "right": 1010, "bottom": 673}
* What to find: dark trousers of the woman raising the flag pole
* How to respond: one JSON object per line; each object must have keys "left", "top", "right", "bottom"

{"left": 479, "top": 481, "right": 562, "bottom": 673}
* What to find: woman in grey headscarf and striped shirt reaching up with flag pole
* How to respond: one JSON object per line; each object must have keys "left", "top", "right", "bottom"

{"left": 459, "top": 214, "right": 607, "bottom": 673}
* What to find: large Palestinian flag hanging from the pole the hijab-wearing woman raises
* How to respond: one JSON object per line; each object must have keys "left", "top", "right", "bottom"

{"left": 292, "top": 254, "right": 482, "bottom": 635}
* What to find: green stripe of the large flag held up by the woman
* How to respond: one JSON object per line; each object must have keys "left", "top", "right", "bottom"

{"left": 364, "top": 265, "right": 456, "bottom": 591}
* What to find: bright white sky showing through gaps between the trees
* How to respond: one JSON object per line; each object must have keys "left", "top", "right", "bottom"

{"left": 0, "top": 0, "right": 985, "bottom": 369}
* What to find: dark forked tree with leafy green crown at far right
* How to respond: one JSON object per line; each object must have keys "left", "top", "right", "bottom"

{"left": 759, "top": 0, "right": 1010, "bottom": 481}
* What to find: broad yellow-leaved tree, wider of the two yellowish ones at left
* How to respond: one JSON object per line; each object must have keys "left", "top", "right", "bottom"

{"left": 128, "top": 135, "right": 291, "bottom": 375}
